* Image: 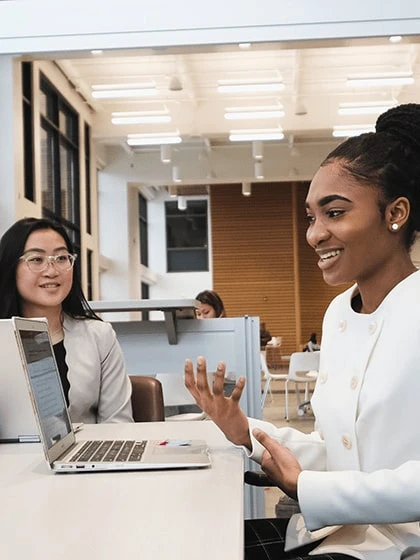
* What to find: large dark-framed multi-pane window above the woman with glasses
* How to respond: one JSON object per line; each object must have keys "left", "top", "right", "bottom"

{"left": 40, "top": 76, "right": 80, "bottom": 253}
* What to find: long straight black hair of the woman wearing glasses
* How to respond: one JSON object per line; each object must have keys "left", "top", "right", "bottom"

{"left": 0, "top": 218, "right": 100, "bottom": 320}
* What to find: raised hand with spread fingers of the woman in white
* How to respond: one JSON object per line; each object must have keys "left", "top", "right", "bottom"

{"left": 184, "top": 356, "right": 252, "bottom": 450}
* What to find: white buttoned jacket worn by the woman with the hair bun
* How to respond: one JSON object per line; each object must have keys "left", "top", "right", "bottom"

{"left": 250, "top": 271, "right": 420, "bottom": 560}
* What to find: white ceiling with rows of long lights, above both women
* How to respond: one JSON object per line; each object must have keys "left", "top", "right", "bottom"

{"left": 27, "top": 36, "right": 420, "bottom": 185}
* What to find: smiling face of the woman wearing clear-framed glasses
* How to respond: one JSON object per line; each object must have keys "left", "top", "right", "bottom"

{"left": 16, "top": 229, "right": 73, "bottom": 317}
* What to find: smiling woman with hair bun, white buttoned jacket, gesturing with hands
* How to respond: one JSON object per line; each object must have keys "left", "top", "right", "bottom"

{"left": 185, "top": 104, "right": 420, "bottom": 560}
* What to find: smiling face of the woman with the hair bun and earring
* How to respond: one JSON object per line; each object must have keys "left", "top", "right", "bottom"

{"left": 306, "top": 161, "right": 402, "bottom": 286}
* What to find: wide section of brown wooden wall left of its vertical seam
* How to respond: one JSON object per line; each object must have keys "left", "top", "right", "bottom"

{"left": 210, "top": 183, "right": 296, "bottom": 349}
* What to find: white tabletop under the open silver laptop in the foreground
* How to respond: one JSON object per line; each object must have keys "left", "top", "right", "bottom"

{"left": 0, "top": 421, "right": 243, "bottom": 560}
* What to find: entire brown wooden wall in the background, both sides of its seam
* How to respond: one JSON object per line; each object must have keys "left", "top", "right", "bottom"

{"left": 210, "top": 183, "right": 352, "bottom": 354}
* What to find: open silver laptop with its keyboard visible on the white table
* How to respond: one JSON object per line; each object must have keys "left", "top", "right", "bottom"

{"left": 12, "top": 317, "right": 211, "bottom": 473}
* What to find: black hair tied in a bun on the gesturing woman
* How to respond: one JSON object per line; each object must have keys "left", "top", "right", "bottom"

{"left": 321, "top": 103, "right": 420, "bottom": 249}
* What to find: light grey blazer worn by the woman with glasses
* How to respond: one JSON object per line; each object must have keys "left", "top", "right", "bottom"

{"left": 63, "top": 315, "right": 133, "bottom": 424}
